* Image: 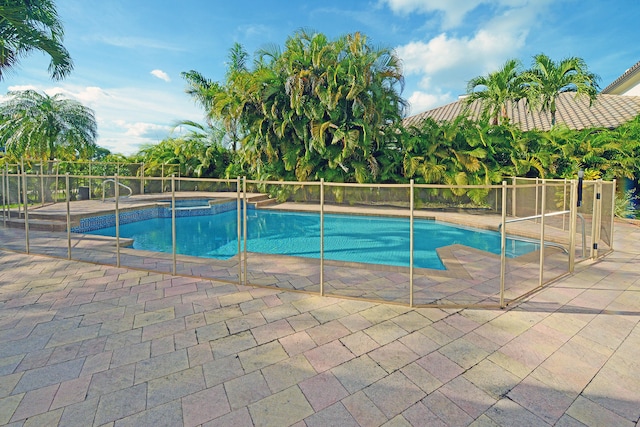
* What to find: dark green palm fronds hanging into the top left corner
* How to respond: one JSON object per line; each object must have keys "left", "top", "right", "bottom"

{"left": 0, "top": 0, "right": 73, "bottom": 80}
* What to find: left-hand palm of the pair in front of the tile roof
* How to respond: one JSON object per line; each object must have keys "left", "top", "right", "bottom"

{"left": 466, "top": 59, "right": 524, "bottom": 125}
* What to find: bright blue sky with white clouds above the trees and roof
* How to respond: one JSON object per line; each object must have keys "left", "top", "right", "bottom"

{"left": 0, "top": 0, "right": 640, "bottom": 155}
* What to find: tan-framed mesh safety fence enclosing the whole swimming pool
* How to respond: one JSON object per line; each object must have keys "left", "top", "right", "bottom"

{"left": 0, "top": 172, "right": 615, "bottom": 306}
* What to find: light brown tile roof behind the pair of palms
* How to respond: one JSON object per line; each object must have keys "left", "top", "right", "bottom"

{"left": 403, "top": 93, "right": 640, "bottom": 131}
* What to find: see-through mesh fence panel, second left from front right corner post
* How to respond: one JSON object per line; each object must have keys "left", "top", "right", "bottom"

{"left": 324, "top": 183, "right": 411, "bottom": 304}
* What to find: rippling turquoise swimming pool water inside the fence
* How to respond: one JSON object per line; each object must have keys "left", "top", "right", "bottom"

{"left": 89, "top": 209, "right": 537, "bottom": 270}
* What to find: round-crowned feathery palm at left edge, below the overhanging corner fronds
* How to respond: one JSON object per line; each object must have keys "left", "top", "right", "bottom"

{"left": 0, "top": 90, "right": 98, "bottom": 161}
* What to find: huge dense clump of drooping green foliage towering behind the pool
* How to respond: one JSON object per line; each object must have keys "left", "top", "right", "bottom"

{"left": 242, "top": 30, "right": 405, "bottom": 182}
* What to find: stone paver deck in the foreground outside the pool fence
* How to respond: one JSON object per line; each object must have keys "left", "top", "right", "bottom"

{"left": 0, "top": 223, "right": 640, "bottom": 427}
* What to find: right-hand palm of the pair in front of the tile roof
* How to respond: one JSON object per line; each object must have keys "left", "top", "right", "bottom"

{"left": 523, "top": 53, "right": 600, "bottom": 126}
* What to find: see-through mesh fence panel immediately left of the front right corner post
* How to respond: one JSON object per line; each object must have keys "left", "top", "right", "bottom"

{"left": 413, "top": 185, "right": 503, "bottom": 306}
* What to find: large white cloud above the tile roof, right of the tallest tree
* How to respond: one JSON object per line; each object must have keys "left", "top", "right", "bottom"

{"left": 385, "top": 0, "right": 550, "bottom": 114}
